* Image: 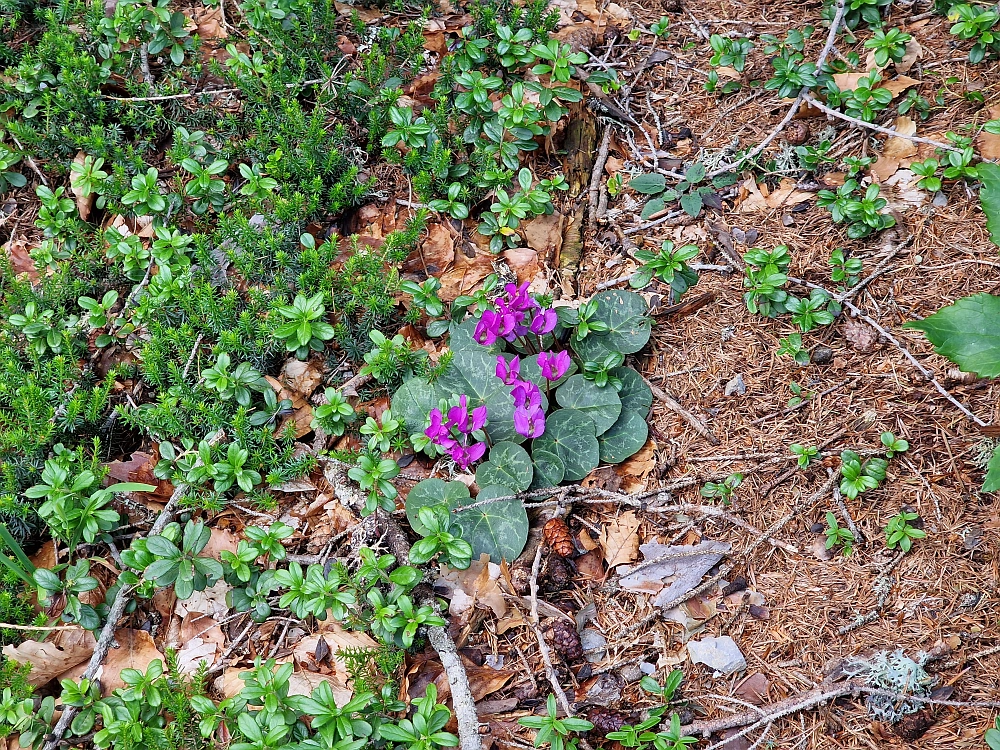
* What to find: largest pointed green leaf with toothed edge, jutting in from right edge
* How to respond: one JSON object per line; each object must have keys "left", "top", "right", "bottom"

{"left": 905, "top": 293, "right": 1000, "bottom": 378}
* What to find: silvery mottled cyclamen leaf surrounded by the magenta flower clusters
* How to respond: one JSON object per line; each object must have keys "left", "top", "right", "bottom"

{"left": 437, "top": 347, "right": 524, "bottom": 443}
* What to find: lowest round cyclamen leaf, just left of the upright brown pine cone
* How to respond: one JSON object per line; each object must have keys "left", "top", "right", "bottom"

{"left": 455, "top": 484, "right": 528, "bottom": 563}
